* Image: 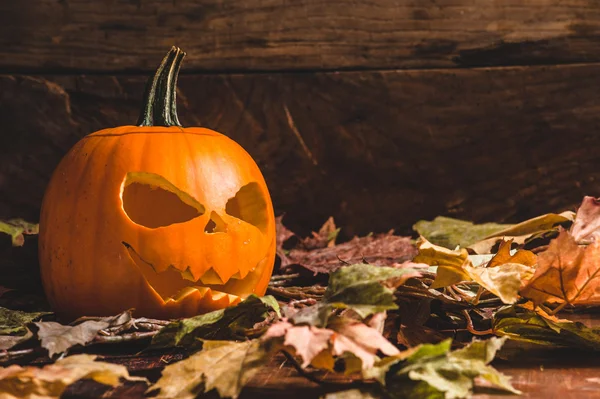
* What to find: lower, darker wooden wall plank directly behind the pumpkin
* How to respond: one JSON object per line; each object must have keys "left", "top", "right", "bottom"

{"left": 0, "top": 65, "right": 600, "bottom": 235}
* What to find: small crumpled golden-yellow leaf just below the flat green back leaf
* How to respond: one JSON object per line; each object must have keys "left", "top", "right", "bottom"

{"left": 414, "top": 237, "right": 471, "bottom": 288}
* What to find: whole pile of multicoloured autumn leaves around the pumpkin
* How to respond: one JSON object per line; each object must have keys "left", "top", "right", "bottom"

{"left": 0, "top": 197, "right": 600, "bottom": 399}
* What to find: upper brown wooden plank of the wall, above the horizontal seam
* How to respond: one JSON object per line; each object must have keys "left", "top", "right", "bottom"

{"left": 0, "top": 0, "right": 600, "bottom": 73}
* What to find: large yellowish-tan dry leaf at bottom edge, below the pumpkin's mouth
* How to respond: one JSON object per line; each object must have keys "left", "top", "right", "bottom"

{"left": 148, "top": 340, "right": 269, "bottom": 399}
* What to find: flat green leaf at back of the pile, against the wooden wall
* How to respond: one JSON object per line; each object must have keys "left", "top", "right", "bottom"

{"left": 413, "top": 216, "right": 513, "bottom": 249}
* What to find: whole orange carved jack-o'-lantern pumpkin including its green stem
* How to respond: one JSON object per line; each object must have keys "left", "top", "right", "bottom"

{"left": 39, "top": 48, "right": 275, "bottom": 318}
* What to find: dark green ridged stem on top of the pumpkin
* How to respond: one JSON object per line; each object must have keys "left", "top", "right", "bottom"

{"left": 137, "top": 46, "right": 185, "bottom": 126}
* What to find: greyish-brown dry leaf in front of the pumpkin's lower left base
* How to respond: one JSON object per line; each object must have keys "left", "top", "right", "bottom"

{"left": 34, "top": 320, "right": 110, "bottom": 357}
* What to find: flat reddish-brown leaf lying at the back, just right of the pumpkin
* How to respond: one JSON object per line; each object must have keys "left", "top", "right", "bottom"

{"left": 287, "top": 233, "right": 417, "bottom": 274}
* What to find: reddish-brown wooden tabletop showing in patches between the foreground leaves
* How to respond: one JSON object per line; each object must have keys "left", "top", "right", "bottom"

{"left": 50, "top": 314, "right": 600, "bottom": 399}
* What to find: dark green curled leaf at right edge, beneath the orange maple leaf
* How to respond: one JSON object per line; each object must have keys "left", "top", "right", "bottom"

{"left": 492, "top": 306, "right": 600, "bottom": 351}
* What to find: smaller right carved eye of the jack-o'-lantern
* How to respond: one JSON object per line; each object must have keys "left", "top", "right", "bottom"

{"left": 225, "top": 182, "right": 268, "bottom": 232}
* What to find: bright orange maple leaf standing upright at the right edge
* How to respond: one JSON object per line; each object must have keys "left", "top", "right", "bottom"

{"left": 521, "top": 230, "right": 600, "bottom": 306}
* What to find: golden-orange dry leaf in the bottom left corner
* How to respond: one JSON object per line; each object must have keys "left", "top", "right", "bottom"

{"left": 0, "top": 355, "right": 146, "bottom": 399}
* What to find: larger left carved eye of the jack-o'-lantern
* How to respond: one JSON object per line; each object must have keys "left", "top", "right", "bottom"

{"left": 121, "top": 172, "right": 204, "bottom": 229}
